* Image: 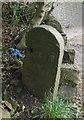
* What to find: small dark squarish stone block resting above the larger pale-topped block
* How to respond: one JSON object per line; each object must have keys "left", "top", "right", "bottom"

{"left": 63, "top": 49, "right": 75, "bottom": 64}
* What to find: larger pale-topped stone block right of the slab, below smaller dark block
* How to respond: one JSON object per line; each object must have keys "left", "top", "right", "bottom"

{"left": 60, "top": 64, "right": 79, "bottom": 86}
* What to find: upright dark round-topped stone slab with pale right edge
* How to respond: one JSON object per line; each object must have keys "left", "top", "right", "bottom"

{"left": 22, "top": 25, "right": 64, "bottom": 99}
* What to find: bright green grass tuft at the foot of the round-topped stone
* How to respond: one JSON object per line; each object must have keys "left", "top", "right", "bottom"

{"left": 33, "top": 92, "right": 73, "bottom": 119}
